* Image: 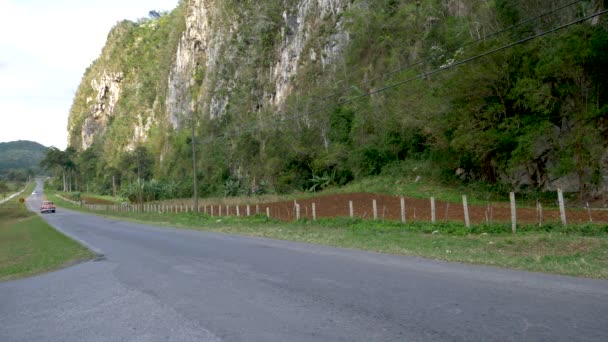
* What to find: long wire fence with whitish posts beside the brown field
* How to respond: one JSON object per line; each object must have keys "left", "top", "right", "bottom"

{"left": 77, "top": 191, "right": 608, "bottom": 231}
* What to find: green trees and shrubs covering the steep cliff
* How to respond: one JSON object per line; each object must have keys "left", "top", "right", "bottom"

{"left": 69, "top": 0, "right": 608, "bottom": 200}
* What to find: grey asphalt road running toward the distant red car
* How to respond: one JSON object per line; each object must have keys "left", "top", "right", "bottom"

{"left": 0, "top": 183, "right": 608, "bottom": 342}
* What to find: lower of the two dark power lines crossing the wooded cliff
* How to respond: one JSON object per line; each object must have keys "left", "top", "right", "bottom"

{"left": 202, "top": 10, "right": 608, "bottom": 144}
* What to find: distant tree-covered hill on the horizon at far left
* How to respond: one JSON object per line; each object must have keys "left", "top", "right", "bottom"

{"left": 0, "top": 140, "right": 47, "bottom": 177}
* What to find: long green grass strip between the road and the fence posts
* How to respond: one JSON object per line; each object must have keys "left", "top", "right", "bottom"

{"left": 45, "top": 188, "right": 608, "bottom": 279}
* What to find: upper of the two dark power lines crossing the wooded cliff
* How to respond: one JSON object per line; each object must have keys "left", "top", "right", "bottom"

{"left": 294, "top": 0, "right": 583, "bottom": 108}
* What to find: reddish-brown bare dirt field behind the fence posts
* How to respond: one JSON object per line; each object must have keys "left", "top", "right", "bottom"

{"left": 224, "top": 193, "right": 608, "bottom": 224}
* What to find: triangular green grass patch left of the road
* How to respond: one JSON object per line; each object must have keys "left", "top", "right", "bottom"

{"left": 0, "top": 185, "right": 93, "bottom": 280}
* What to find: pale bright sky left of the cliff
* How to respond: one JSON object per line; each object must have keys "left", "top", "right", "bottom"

{"left": 0, "top": 0, "right": 178, "bottom": 150}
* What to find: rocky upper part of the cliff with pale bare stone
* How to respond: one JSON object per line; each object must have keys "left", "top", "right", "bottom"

{"left": 69, "top": 0, "right": 350, "bottom": 150}
